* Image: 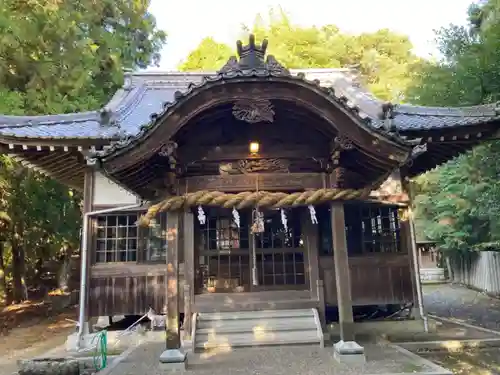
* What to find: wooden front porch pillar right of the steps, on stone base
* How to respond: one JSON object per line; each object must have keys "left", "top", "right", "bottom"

{"left": 331, "top": 203, "right": 355, "bottom": 341}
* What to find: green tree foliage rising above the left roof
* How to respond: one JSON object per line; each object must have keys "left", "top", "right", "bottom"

{"left": 0, "top": 0, "right": 165, "bottom": 114}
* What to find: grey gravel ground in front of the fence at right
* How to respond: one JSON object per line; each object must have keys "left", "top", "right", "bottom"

{"left": 423, "top": 284, "right": 500, "bottom": 331}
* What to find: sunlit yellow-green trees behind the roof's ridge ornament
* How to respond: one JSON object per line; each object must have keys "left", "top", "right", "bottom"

{"left": 179, "top": 10, "right": 421, "bottom": 101}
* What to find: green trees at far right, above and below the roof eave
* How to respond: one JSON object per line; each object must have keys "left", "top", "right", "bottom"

{"left": 408, "top": 0, "right": 500, "bottom": 251}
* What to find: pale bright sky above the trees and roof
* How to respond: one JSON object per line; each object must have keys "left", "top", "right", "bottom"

{"left": 150, "top": 0, "right": 472, "bottom": 70}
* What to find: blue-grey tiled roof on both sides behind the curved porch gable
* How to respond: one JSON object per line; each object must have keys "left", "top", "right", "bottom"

{"left": 0, "top": 69, "right": 499, "bottom": 139}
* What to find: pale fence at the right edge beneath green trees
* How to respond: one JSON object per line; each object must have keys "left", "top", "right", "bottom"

{"left": 450, "top": 251, "right": 500, "bottom": 295}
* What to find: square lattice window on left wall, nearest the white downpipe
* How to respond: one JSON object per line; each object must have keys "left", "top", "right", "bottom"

{"left": 95, "top": 214, "right": 139, "bottom": 263}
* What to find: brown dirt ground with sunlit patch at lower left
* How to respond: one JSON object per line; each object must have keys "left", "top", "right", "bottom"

{"left": 0, "top": 302, "right": 76, "bottom": 375}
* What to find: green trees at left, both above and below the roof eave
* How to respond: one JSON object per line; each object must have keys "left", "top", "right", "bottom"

{"left": 0, "top": 0, "right": 166, "bottom": 301}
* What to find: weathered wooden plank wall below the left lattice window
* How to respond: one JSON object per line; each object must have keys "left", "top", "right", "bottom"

{"left": 89, "top": 263, "right": 184, "bottom": 316}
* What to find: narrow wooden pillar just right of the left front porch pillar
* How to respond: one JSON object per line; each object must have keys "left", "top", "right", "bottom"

{"left": 183, "top": 211, "right": 194, "bottom": 340}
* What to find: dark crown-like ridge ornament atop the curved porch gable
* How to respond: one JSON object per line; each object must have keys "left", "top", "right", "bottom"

{"left": 217, "top": 34, "right": 291, "bottom": 76}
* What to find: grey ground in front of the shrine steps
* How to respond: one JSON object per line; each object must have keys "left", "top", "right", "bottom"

{"left": 105, "top": 343, "right": 438, "bottom": 375}
